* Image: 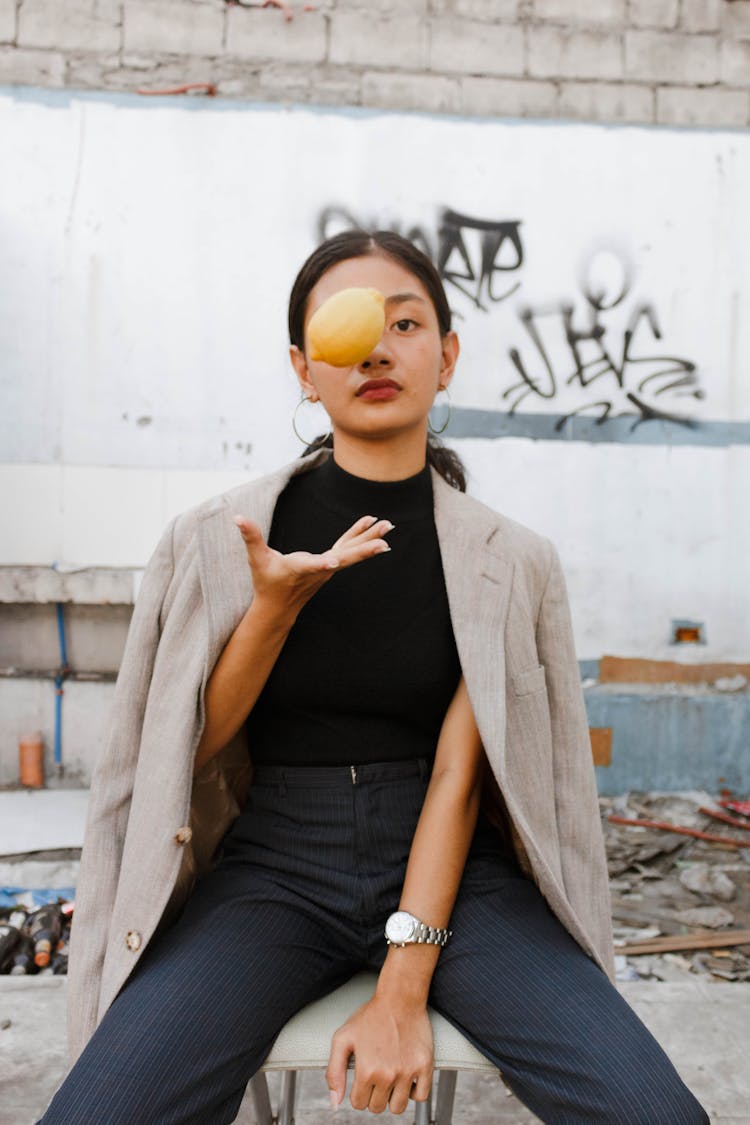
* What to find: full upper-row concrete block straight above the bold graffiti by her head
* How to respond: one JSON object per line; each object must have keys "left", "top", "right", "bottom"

{"left": 430, "top": 19, "right": 524, "bottom": 74}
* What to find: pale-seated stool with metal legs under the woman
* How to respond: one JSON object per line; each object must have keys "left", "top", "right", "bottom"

{"left": 249, "top": 972, "right": 498, "bottom": 1125}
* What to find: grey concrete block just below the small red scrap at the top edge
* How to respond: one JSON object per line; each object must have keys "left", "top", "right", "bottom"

{"left": 226, "top": 8, "right": 326, "bottom": 63}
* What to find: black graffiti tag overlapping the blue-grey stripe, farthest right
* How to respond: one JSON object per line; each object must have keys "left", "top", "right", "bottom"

{"left": 501, "top": 253, "right": 704, "bottom": 430}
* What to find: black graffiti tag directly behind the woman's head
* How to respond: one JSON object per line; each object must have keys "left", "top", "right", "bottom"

{"left": 318, "top": 206, "right": 524, "bottom": 316}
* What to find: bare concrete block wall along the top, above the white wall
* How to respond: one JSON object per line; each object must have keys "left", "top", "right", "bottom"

{"left": 0, "top": 0, "right": 750, "bottom": 127}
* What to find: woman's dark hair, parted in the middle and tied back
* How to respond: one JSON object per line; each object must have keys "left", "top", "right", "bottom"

{"left": 289, "top": 230, "right": 467, "bottom": 492}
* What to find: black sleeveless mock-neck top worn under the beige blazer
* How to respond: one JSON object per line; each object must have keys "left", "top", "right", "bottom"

{"left": 246, "top": 457, "right": 461, "bottom": 765}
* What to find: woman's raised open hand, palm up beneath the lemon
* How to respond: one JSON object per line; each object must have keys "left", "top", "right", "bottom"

{"left": 234, "top": 515, "right": 394, "bottom": 619}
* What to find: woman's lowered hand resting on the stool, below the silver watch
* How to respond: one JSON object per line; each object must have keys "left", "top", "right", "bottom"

{"left": 326, "top": 996, "right": 433, "bottom": 1114}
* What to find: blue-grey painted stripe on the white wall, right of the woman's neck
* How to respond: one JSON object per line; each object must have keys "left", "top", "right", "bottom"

{"left": 445, "top": 406, "right": 750, "bottom": 446}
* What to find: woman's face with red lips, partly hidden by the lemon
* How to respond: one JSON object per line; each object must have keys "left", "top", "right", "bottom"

{"left": 290, "top": 254, "right": 459, "bottom": 439}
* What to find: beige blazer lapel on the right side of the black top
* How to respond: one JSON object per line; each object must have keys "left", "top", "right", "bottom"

{"left": 433, "top": 470, "right": 513, "bottom": 781}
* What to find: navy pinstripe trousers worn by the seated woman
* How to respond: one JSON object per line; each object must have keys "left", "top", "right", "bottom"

{"left": 40, "top": 762, "right": 708, "bottom": 1125}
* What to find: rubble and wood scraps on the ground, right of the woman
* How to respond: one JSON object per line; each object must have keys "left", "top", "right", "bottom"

{"left": 599, "top": 793, "right": 750, "bottom": 981}
